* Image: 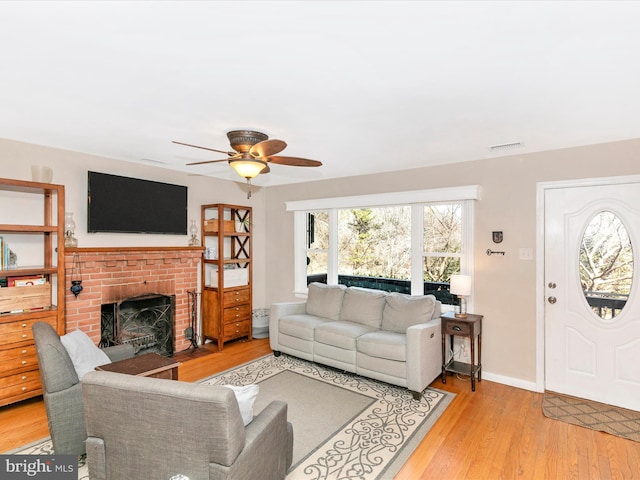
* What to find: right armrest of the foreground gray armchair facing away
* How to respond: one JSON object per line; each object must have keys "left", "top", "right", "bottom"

{"left": 209, "top": 400, "right": 293, "bottom": 479}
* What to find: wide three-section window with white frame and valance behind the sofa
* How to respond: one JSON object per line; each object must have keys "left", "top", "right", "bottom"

{"left": 287, "top": 186, "right": 480, "bottom": 308}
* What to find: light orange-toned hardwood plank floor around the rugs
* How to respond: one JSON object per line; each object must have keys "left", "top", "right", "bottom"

{"left": 0, "top": 340, "right": 640, "bottom": 480}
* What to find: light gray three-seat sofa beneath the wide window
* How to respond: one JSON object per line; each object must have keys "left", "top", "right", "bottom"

{"left": 269, "top": 283, "right": 442, "bottom": 399}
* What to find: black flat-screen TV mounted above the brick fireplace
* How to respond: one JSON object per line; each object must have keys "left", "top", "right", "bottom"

{"left": 87, "top": 172, "right": 187, "bottom": 235}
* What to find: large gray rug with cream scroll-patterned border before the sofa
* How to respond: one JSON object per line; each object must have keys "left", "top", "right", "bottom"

{"left": 6, "top": 355, "right": 454, "bottom": 480}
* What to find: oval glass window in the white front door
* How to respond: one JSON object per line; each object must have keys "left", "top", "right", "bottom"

{"left": 580, "top": 212, "right": 633, "bottom": 320}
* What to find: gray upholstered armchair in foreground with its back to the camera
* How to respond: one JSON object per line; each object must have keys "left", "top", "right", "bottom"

{"left": 82, "top": 371, "right": 293, "bottom": 480}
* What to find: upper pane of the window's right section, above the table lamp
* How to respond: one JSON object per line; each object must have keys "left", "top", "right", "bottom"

{"left": 424, "top": 203, "right": 462, "bottom": 253}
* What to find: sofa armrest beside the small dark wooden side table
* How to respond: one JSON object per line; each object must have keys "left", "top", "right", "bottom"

{"left": 407, "top": 318, "right": 442, "bottom": 392}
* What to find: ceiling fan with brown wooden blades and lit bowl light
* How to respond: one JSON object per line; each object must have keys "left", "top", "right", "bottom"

{"left": 173, "top": 130, "right": 322, "bottom": 194}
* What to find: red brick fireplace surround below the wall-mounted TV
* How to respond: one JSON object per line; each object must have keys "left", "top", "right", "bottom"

{"left": 65, "top": 247, "right": 203, "bottom": 352}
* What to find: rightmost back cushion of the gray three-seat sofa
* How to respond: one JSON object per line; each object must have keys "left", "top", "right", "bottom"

{"left": 382, "top": 293, "right": 436, "bottom": 333}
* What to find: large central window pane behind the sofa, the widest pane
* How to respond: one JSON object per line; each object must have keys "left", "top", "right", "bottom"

{"left": 338, "top": 206, "right": 411, "bottom": 291}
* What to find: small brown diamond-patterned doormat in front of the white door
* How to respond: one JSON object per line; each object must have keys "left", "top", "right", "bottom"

{"left": 542, "top": 392, "right": 640, "bottom": 442}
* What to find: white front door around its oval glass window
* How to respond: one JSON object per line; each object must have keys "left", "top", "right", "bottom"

{"left": 544, "top": 183, "right": 640, "bottom": 410}
